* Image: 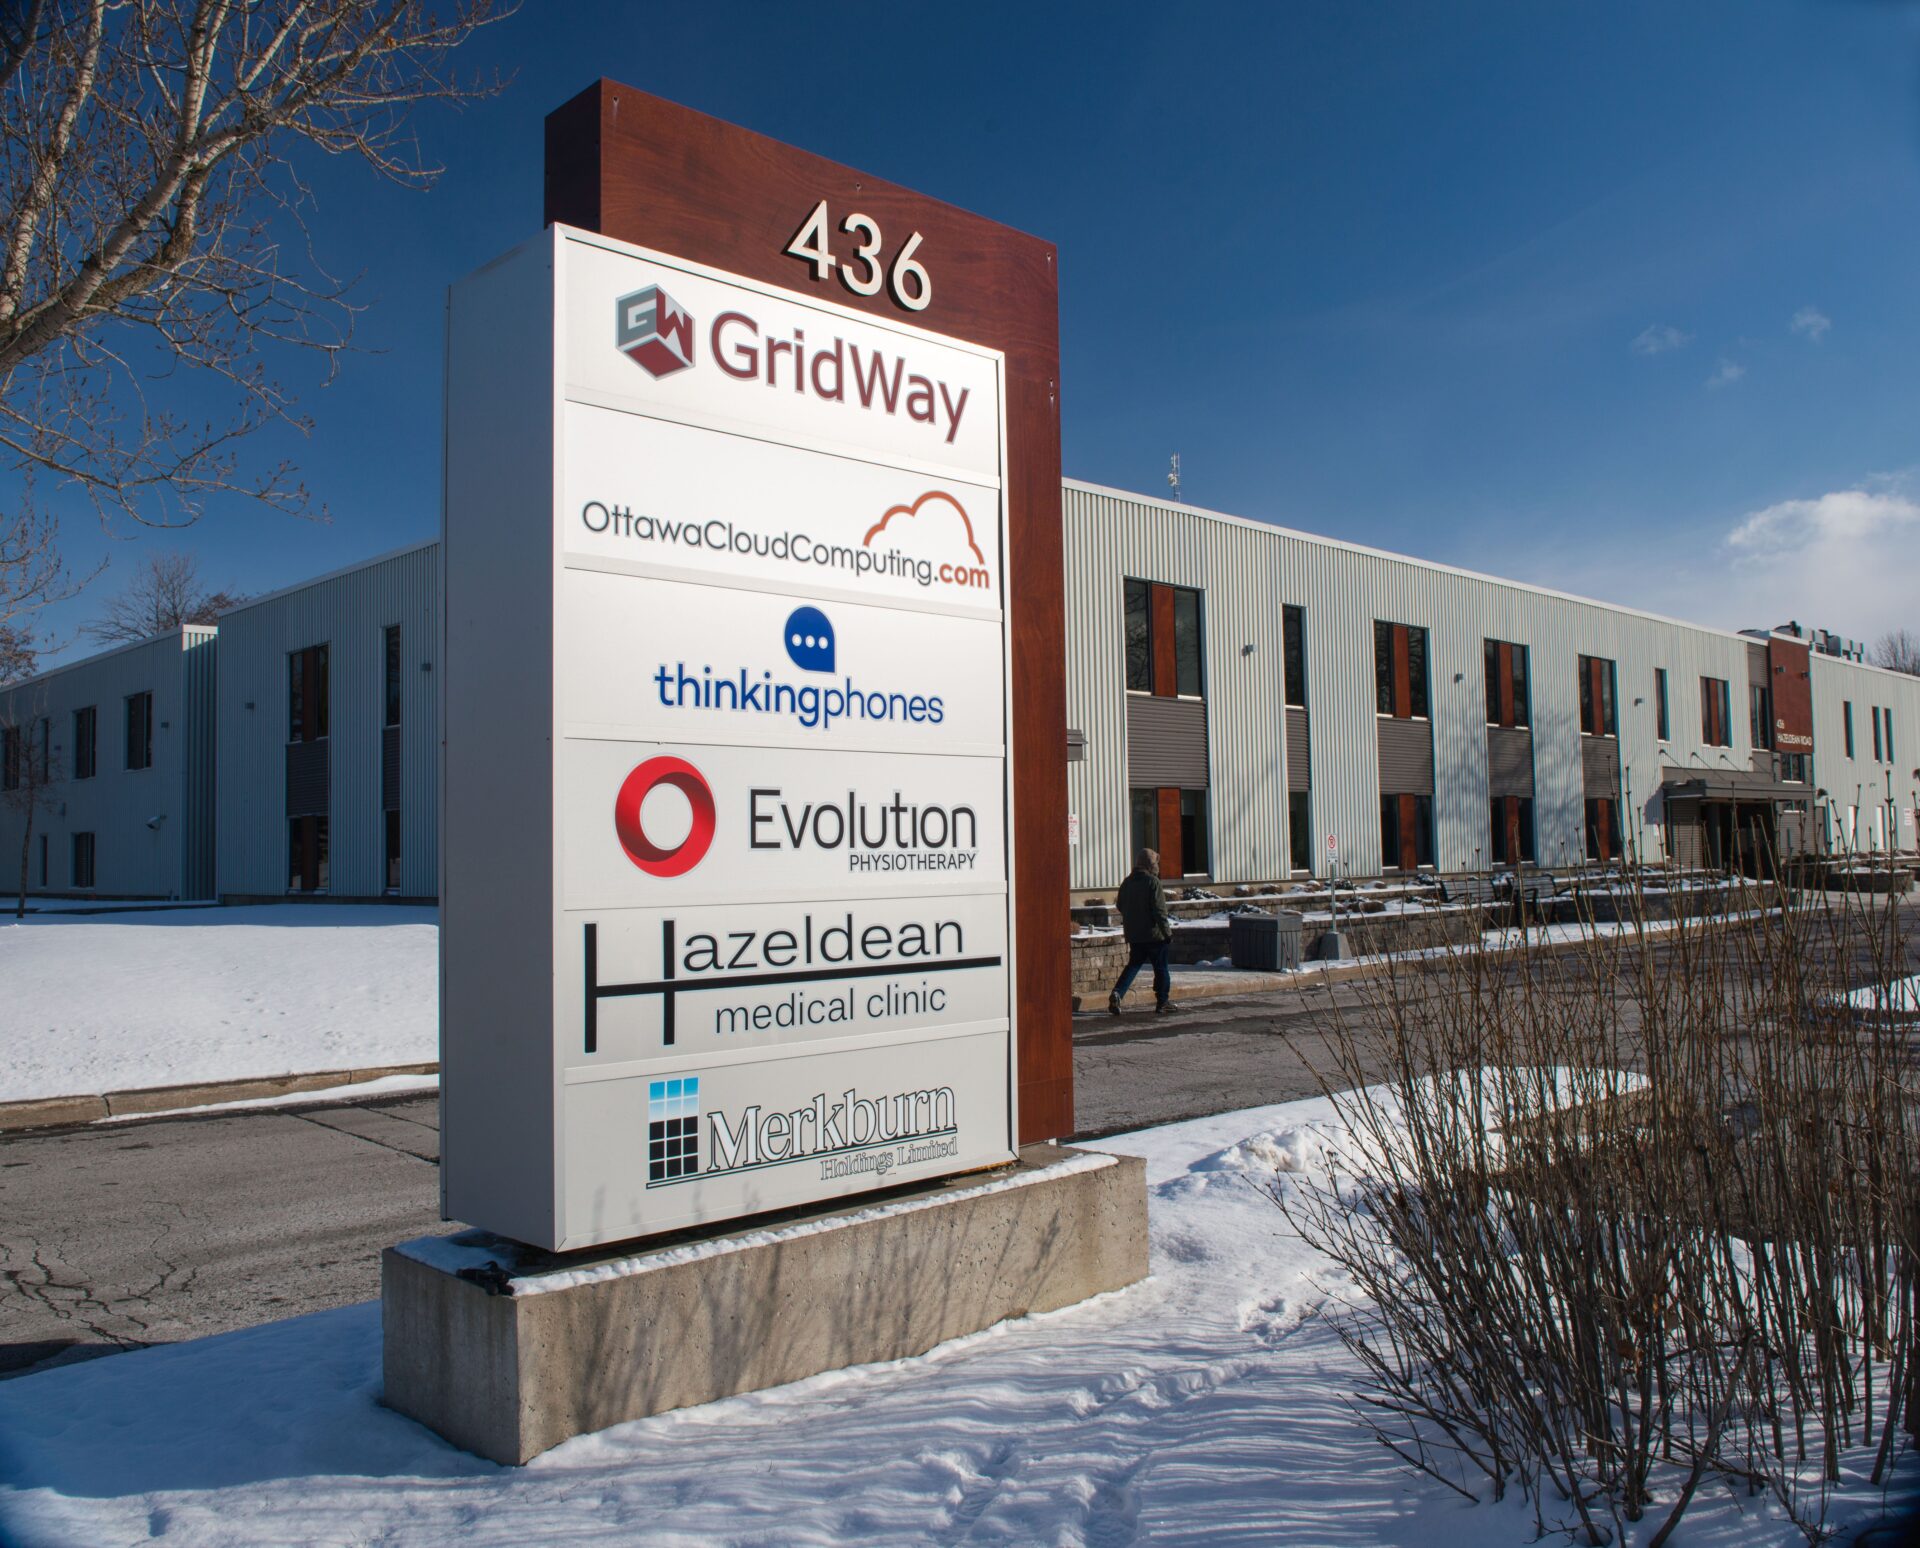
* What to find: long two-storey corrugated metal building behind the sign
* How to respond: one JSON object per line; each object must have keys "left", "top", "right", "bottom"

{"left": 0, "top": 480, "right": 1920, "bottom": 901}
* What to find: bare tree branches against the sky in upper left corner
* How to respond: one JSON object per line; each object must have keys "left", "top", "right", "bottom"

{"left": 0, "top": 0, "right": 515, "bottom": 637}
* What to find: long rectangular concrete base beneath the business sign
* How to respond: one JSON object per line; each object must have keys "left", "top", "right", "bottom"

{"left": 380, "top": 1145, "right": 1146, "bottom": 1463}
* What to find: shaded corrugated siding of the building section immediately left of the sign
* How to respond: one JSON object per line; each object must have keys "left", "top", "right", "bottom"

{"left": 219, "top": 544, "right": 439, "bottom": 897}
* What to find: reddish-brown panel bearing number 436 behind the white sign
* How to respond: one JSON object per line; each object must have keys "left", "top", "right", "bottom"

{"left": 545, "top": 81, "right": 1075, "bottom": 1145}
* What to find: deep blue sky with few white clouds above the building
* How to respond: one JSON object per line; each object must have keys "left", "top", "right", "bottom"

{"left": 26, "top": 0, "right": 1920, "bottom": 660}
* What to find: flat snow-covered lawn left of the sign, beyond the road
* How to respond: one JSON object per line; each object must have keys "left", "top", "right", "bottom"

{"left": 0, "top": 903, "right": 440, "bottom": 1101}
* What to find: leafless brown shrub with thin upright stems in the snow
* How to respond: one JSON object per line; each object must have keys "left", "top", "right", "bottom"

{"left": 1275, "top": 872, "right": 1920, "bottom": 1546}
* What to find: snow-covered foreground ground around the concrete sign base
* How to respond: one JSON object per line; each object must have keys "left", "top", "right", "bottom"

{"left": 0, "top": 1101, "right": 1920, "bottom": 1548}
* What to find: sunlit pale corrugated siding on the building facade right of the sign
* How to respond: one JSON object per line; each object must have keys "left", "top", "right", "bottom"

{"left": 1062, "top": 482, "right": 1766, "bottom": 889}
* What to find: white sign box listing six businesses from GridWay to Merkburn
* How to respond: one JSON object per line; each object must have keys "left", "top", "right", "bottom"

{"left": 444, "top": 230, "right": 1016, "bottom": 1248}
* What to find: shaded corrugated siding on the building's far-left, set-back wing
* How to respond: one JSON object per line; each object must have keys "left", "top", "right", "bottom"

{"left": 0, "top": 628, "right": 213, "bottom": 897}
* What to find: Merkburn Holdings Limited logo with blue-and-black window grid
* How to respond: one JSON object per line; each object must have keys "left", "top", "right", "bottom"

{"left": 647, "top": 1077, "right": 960, "bottom": 1189}
